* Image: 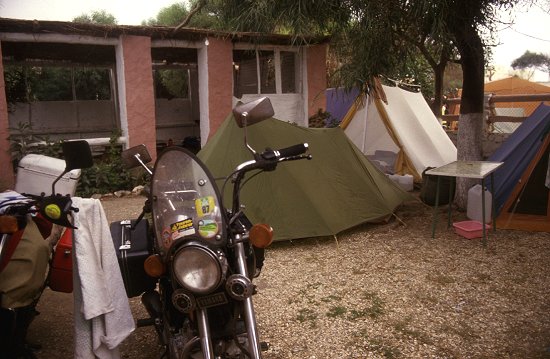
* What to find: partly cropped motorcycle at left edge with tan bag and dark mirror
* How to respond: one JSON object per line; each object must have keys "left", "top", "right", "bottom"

{"left": 0, "top": 141, "right": 92, "bottom": 359}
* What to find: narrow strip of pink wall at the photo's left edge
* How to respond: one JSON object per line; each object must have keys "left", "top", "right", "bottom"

{"left": 0, "top": 45, "right": 15, "bottom": 191}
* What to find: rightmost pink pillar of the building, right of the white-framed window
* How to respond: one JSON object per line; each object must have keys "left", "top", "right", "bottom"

{"left": 306, "top": 44, "right": 327, "bottom": 116}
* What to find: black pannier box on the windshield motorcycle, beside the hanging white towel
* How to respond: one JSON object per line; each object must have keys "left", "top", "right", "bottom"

{"left": 111, "top": 220, "right": 157, "bottom": 298}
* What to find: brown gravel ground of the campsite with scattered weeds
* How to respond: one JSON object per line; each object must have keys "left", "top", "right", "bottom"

{"left": 29, "top": 197, "right": 550, "bottom": 359}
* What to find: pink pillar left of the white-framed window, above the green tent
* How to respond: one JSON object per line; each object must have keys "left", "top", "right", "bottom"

{"left": 208, "top": 38, "right": 233, "bottom": 138}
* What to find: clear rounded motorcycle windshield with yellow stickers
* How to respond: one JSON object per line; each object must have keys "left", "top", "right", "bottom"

{"left": 151, "top": 147, "right": 225, "bottom": 256}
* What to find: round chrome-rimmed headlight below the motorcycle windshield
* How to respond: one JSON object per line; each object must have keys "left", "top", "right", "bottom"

{"left": 172, "top": 245, "right": 227, "bottom": 294}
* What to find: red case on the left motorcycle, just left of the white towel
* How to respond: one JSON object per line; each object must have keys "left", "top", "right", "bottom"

{"left": 48, "top": 228, "right": 73, "bottom": 293}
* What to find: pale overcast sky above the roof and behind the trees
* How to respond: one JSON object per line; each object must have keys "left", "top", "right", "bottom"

{"left": 0, "top": 0, "right": 550, "bottom": 81}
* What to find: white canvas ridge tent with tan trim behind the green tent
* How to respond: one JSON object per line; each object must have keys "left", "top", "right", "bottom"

{"left": 340, "top": 85, "right": 456, "bottom": 181}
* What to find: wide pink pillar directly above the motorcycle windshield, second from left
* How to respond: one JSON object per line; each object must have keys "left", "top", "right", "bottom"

{"left": 121, "top": 36, "right": 156, "bottom": 160}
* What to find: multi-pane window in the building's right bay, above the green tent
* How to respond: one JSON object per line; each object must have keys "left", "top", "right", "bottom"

{"left": 233, "top": 49, "right": 299, "bottom": 97}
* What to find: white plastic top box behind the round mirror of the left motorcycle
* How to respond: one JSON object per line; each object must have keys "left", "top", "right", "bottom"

{"left": 15, "top": 154, "right": 82, "bottom": 196}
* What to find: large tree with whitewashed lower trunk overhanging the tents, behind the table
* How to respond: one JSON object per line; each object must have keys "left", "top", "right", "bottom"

{"left": 213, "top": 0, "right": 517, "bottom": 207}
